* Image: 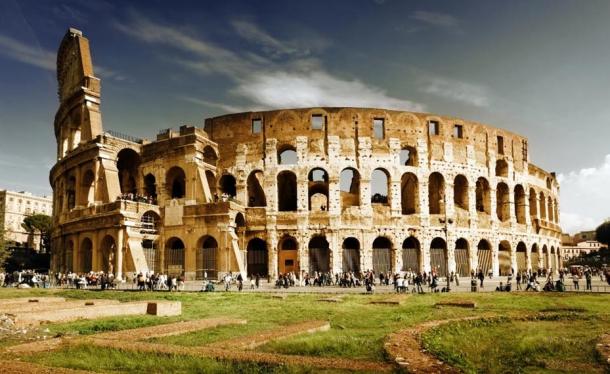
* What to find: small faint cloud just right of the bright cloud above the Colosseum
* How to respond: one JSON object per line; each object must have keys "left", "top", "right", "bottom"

{"left": 420, "top": 77, "right": 490, "bottom": 107}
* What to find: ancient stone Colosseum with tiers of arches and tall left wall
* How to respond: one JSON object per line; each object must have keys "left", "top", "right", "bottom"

{"left": 50, "top": 29, "right": 561, "bottom": 280}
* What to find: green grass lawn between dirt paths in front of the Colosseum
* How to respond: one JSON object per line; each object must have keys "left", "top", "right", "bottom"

{"left": 0, "top": 289, "right": 610, "bottom": 373}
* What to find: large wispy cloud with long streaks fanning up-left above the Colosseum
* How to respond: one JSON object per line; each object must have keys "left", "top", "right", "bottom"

{"left": 117, "top": 14, "right": 423, "bottom": 111}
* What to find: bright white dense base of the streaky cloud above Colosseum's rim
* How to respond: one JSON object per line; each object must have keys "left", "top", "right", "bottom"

{"left": 233, "top": 71, "right": 424, "bottom": 111}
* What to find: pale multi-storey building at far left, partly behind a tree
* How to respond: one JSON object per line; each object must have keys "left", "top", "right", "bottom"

{"left": 0, "top": 190, "right": 53, "bottom": 250}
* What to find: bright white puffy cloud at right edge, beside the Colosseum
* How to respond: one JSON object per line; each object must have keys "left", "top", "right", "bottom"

{"left": 557, "top": 154, "right": 610, "bottom": 233}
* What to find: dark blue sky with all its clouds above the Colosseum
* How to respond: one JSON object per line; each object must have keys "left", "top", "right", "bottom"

{"left": 0, "top": 0, "right": 610, "bottom": 231}
